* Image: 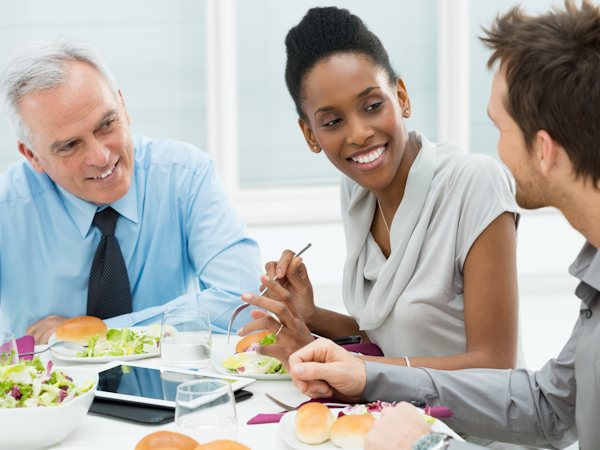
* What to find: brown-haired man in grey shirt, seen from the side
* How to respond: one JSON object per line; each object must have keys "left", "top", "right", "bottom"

{"left": 289, "top": 0, "right": 600, "bottom": 450}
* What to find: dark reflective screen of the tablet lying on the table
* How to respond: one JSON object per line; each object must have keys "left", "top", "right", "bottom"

{"left": 97, "top": 366, "right": 235, "bottom": 402}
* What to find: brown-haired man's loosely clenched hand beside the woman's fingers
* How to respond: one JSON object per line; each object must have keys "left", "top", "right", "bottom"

{"left": 289, "top": 339, "right": 367, "bottom": 402}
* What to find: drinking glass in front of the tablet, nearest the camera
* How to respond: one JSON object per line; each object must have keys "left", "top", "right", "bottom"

{"left": 175, "top": 380, "right": 237, "bottom": 444}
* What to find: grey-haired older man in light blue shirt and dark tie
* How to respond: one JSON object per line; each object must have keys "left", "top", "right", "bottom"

{"left": 0, "top": 37, "right": 261, "bottom": 343}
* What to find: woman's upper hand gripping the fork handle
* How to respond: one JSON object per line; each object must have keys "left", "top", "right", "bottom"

{"left": 260, "top": 250, "right": 316, "bottom": 327}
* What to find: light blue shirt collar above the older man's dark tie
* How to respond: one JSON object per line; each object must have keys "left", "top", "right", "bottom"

{"left": 56, "top": 177, "right": 138, "bottom": 238}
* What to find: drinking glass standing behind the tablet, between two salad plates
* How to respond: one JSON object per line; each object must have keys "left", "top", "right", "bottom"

{"left": 160, "top": 306, "right": 212, "bottom": 369}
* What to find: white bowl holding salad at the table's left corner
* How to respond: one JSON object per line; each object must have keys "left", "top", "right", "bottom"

{"left": 0, "top": 367, "right": 98, "bottom": 450}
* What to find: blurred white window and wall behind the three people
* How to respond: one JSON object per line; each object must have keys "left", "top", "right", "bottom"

{"left": 0, "top": 0, "right": 583, "bottom": 369}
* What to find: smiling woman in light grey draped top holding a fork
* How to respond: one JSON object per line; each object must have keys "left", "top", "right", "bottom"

{"left": 241, "top": 7, "right": 518, "bottom": 380}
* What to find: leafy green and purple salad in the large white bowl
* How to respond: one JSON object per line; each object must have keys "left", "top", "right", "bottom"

{"left": 0, "top": 351, "right": 94, "bottom": 409}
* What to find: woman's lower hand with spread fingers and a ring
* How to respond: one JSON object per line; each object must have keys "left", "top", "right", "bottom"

{"left": 238, "top": 275, "right": 314, "bottom": 372}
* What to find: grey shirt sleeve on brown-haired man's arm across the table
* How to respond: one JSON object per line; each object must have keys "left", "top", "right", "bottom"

{"left": 361, "top": 319, "right": 581, "bottom": 450}
